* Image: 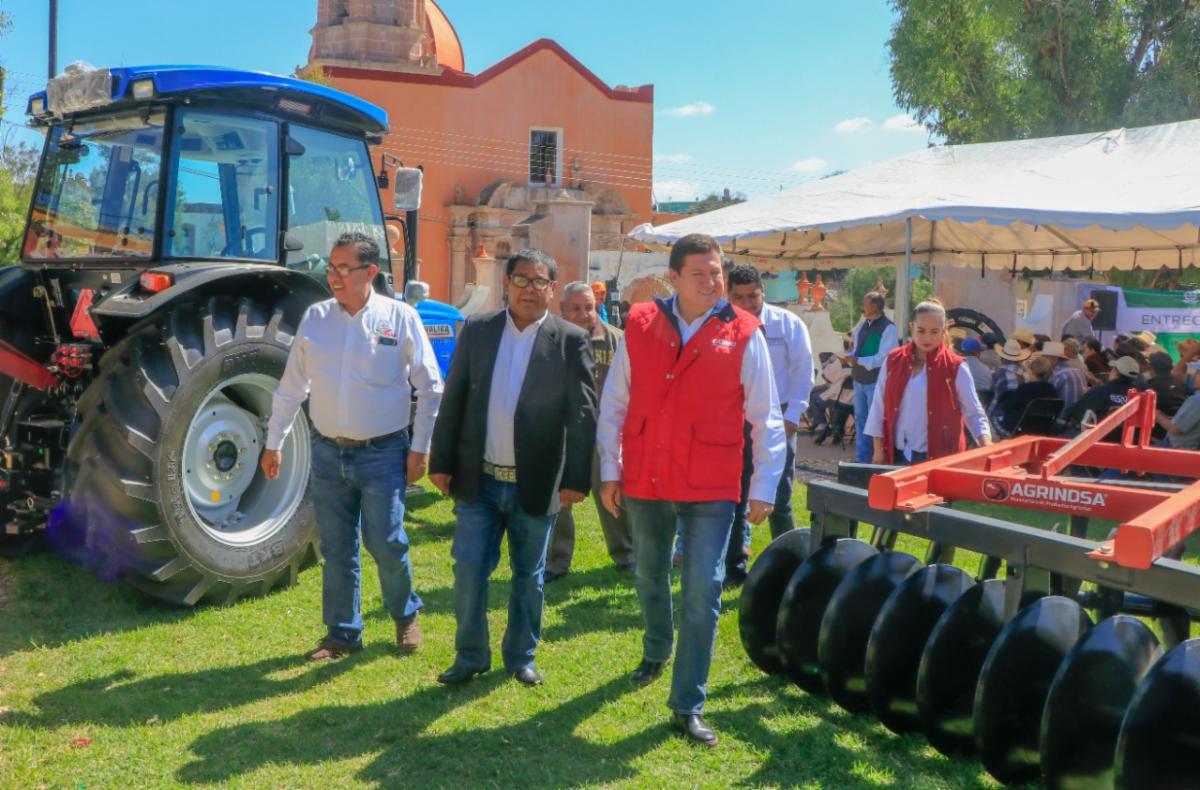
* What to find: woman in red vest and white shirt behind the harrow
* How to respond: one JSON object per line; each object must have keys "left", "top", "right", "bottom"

{"left": 865, "top": 301, "right": 991, "bottom": 465}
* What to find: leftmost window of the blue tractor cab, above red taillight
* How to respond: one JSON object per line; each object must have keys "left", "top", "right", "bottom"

{"left": 23, "top": 113, "right": 166, "bottom": 261}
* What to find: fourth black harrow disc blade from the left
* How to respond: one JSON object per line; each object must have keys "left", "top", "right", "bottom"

{"left": 866, "top": 564, "right": 974, "bottom": 734}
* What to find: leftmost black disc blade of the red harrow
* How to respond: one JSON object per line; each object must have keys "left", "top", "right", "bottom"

{"left": 738, "top": 529, "right": 810, "bottom": 675}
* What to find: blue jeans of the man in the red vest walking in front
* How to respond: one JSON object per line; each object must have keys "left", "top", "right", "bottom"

{"left": 625, "top": 497, "right": 734, "bottom": 713}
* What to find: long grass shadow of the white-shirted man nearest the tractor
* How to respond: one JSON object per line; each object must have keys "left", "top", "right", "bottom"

{"left": 6, "top": 652, "right": 371, "bottom": 730}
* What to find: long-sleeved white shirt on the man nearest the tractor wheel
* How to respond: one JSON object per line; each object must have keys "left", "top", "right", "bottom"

{"left": 266, "top": 291, "right": 442, "bottom": 453}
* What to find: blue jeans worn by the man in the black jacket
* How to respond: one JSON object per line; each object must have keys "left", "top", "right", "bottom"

{"left": 450, "top": 474, "right": 554, "bottom": 672}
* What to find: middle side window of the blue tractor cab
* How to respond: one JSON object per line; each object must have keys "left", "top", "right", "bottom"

{"left": 163, "top": 110, "right": 280, "bottom": 261}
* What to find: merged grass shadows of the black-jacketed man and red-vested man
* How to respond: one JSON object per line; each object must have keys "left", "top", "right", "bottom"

{"left": 176, "top": 671, "right": 667, "bottom": 788}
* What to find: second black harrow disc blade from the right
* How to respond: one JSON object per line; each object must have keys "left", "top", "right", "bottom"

{"left": 1042, "top": 615, "right": 1163, "bottom": 788}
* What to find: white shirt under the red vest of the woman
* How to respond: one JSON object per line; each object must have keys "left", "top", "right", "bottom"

{"left": 865, "top": 352, "right": 991, "bottom": 460}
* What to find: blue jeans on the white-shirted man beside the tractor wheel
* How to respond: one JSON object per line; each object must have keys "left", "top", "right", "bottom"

{"left": 312, "top": 433, "right": 421, "bottom": 645}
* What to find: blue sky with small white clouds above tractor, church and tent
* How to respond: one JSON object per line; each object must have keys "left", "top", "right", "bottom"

{"left": 0, "top": 0, "right": 929, "bottom": 201}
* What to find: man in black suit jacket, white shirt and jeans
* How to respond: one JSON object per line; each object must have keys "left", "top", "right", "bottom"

{"left": 430, "top": 250, "right": 598, "bottom": 686}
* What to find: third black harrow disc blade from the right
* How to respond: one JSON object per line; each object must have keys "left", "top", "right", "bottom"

{"left": 974, "top": 596, "right": 1092, "bottom": 783}
